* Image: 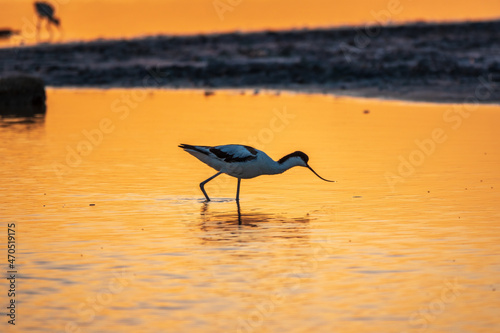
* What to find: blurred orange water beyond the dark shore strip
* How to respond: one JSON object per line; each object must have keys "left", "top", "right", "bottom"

{"left": 0, "top": 0, "right": 500, "bottom": 45}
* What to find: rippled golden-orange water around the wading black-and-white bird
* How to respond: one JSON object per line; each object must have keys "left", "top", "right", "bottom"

{"left": 0, "top": 90, "right": 500, "bottom": 333}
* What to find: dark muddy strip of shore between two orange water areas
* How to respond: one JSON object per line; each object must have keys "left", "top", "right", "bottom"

{"left": 0, "top": 21, "right": 500, "bottom": 103}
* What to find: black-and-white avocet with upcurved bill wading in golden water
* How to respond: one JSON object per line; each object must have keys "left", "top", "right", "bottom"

{"left": 179, "top": 144, "right": 335, "bottom": 201}
